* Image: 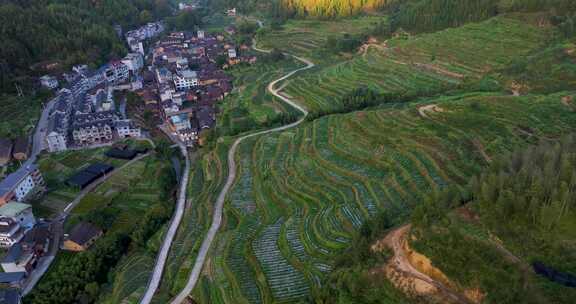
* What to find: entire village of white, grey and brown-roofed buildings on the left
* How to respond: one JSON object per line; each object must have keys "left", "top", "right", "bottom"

{"left": 0, "top": 11, "right": 256, "bottom": 300}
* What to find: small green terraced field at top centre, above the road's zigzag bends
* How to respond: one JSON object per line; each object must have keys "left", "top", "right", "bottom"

{"left": 257, "top": 16, "right": 383, "bottom": 59}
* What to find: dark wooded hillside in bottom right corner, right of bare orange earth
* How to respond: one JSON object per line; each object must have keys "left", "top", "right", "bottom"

{"left": 412, "top": 135, "right": 576, "bottom": 303}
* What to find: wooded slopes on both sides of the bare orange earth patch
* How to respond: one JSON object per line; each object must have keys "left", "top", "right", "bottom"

{"left": 324, "top": 131, "right": 576, "bottom": 304}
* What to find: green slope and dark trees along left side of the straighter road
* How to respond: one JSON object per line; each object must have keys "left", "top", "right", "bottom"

{"left": 25, "top": 149, "right": 176, "bottom": 303}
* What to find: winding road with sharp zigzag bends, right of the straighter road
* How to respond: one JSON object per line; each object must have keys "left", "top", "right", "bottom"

{"left": 169, "top": 39, "right": 314, "bottom": 304}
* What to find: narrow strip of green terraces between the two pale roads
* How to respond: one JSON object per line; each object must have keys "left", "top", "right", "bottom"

{"left": 150, "top": 139, "right": 231, "bottom": 304}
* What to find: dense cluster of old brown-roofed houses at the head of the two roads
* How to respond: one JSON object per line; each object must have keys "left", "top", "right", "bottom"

{"left": 141, "top": 30, "right": 256, "bottom": 145}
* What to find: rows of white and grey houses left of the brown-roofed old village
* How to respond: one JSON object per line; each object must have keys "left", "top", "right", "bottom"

{"left": 45, "top": 53, "right": 144, "bottom": 152}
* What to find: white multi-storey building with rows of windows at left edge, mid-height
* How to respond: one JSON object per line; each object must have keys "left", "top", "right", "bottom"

{"left": 0, "top": 164, "right": 44, "bottom": 206}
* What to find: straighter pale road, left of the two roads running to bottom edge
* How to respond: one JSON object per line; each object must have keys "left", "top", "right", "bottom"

{"left": 140, "top": 144, "right": 190, "bottom": 304}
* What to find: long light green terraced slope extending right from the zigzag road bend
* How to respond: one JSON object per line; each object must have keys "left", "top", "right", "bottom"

{"left": 285, "top": 17, "right": 550, "bottom": 111}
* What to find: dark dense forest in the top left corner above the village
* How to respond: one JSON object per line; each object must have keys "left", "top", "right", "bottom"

{"left": 0, "top": 0, "right": 172, "bottom": 93}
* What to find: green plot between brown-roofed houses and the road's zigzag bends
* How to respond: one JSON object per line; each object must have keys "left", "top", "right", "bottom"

{"left": 218, "top": 57, "right": 299, "bottom": 134}
